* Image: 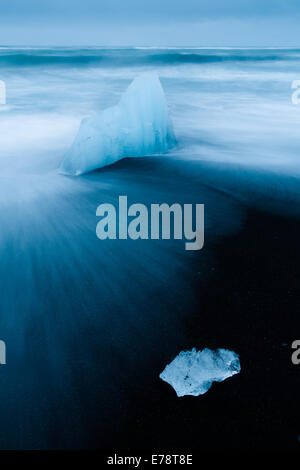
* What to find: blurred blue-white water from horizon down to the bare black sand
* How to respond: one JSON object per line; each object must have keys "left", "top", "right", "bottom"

{"left": 0, "top": 48, "right": 300, "bottom": 448}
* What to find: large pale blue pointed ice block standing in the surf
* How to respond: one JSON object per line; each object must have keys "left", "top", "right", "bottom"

{"left": 60, "top": 73, "right": 176, "bottom": 175}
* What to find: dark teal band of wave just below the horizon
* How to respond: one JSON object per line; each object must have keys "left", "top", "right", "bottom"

{"left": 0, "top": 48, "right": 300, "bottom": 67}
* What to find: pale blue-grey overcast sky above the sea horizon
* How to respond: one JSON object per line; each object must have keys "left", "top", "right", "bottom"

{"left": 0, "top": 0, "right": 300, "bottom": 47}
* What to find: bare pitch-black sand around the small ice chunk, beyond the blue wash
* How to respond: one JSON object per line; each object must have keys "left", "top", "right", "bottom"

{"left": 100, "top": 209, "right": 300, "bottom": 453}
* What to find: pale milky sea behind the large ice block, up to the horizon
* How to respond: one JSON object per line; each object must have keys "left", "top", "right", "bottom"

{"left": 0, "top": 48, "right": 300, "bottom": 171}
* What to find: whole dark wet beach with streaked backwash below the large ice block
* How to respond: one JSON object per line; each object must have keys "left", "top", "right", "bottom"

{"left": 0, "top": 159, "right": 300, "bottom": 454}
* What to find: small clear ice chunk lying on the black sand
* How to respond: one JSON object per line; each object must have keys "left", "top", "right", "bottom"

{"left": 159, "top": 348, "right": 241, "bottom": 397}
